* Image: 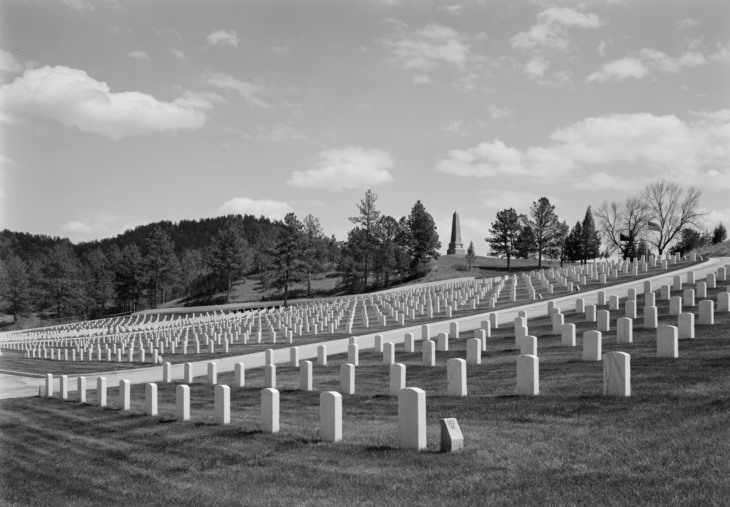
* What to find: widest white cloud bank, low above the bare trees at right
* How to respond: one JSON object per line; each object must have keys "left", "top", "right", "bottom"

{"left": 436, "top": 109, "right": 730, "bottom": 189}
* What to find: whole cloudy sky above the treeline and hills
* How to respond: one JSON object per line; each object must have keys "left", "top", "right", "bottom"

{"left": 0, "top": 0, "right": 730, "bottom": 255}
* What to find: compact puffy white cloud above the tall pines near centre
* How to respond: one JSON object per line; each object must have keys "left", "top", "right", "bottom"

{"left": 287, "top": 146, "right": 394, "bottom": 191}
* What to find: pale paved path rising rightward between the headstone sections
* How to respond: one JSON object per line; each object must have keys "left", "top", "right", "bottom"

{"left": 0, "top": 257, "right": 730, "bottom": 399}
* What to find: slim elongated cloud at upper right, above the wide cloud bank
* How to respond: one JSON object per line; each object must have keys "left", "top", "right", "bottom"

{"left": 586, "top": 48, "right": 714, "bottom": 83}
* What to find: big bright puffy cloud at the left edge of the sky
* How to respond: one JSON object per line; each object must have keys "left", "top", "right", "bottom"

{"left": 0, "top": 66, "right": 206, "bottom": 141}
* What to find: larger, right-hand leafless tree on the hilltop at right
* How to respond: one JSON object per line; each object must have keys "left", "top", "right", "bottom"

{"left": 642, "top": 180, "right": 707, "bottom": 255}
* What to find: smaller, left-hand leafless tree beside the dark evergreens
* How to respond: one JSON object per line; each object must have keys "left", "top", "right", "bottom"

{"left": 595, "top": 195, "right": 649, "bottom": 260}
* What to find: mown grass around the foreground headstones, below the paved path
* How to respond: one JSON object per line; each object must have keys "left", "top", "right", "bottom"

{"left": 0, "top": 284, "right": 730, "bottom": 505}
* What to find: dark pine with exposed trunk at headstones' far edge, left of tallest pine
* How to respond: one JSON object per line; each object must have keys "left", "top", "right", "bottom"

{"left": 272, "top": 213, "right": 304, "bottom": 306}
